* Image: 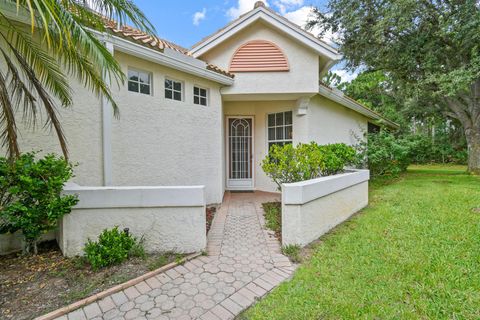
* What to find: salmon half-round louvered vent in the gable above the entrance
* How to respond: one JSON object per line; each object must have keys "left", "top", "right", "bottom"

{"left": 229, "top": 40, "right": 290, "bottom": 72}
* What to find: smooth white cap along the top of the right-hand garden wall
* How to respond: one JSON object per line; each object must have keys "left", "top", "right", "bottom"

{"left": 282, "top": 170, "right": 370, "bottom": 205}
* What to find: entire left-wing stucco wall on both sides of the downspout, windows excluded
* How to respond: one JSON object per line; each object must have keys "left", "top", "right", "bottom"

{"left": 3, "top": 52, "right": 224, "bottom": 203}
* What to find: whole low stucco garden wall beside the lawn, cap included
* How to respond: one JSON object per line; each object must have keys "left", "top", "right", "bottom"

{"left": 282, "top": 170, "right": 370, "bottom": 246}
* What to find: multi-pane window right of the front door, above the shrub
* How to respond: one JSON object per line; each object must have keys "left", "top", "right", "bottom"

{"left": 267, "top": 111, "right": 293, "bottom": 150}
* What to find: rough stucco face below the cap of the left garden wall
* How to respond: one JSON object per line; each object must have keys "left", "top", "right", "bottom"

{"left": 58, "top": 206, "right": 207, "bottom": 257}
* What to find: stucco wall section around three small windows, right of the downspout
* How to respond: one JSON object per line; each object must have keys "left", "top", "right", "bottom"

{"left": 112, "top": 53, "right": 223, "bottom": 203}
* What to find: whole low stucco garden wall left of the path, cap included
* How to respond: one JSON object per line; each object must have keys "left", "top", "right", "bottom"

{"left": 58, "top": 185, "right": 207, "bottom": 256}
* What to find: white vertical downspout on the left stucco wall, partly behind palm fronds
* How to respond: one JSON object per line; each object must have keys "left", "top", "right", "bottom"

{"left": 101, "top": 39, "right": 114, "bottom": 186}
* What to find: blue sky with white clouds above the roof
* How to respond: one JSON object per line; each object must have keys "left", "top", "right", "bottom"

{"left": 134, "top": 0, "right": 355, "bottom": 81}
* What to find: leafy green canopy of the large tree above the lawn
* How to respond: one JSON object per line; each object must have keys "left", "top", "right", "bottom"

{"left": 309, "top": 0, "right": 480, "bottom": 174}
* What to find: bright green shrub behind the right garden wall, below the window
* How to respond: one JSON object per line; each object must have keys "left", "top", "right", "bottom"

{"left": 262, "top": 142, "right": 356, "bottom": 190}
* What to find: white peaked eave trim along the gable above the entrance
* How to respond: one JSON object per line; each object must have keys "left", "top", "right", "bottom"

{"left": 189, "top": 7, "right": 342, "bottom": 61}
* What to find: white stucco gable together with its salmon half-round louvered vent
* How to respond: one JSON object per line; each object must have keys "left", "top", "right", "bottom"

{"left": 199, "top": 22, "right": 320, "bottom": 94}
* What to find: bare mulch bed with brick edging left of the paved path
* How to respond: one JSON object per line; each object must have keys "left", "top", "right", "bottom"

{"left": 0, "top": 241, "right": 182, "bottom": 320}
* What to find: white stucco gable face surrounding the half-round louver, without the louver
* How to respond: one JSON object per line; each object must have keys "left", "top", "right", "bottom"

{"left": 200, "top": 22, "right": 319, "bottom": 94}
